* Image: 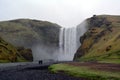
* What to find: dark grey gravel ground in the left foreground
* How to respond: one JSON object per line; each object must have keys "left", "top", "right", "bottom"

{"left": 0, "top": 63, "right": 85, "bottom": 80}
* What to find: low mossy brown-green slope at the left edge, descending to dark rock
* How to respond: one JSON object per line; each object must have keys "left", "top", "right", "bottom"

{"left": 0, "top": 38, "right": 26, "bottom": 63}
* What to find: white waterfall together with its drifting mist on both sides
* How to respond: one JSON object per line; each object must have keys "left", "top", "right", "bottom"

{"left": 32, "top": 21, "right": 87, "bottom": 61}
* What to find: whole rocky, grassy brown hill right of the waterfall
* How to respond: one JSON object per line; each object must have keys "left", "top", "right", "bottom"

{"left": 74, "top": 15, "right": 120, "bottom": 61}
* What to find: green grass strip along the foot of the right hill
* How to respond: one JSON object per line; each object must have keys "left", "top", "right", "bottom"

{"left": 77, "top": 50, "right": 120, "bottom": 64}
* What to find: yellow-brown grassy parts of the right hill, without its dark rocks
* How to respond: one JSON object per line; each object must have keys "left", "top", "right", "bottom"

{"left": 74, "top": 15, "right": 120, "bottom": 63}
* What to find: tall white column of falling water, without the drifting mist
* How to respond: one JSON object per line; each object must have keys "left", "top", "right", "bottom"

{"left": 58, "top": 27, "right": 77, "bottom": 61}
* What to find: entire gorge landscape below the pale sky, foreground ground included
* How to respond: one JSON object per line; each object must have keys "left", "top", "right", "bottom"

{"left": 0, "top": 15, "right": 120, "bottom": 80}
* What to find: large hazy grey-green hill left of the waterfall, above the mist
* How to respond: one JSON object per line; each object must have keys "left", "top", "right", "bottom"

{"left": 0, "top": 19, "right": 60, "bottom": 48}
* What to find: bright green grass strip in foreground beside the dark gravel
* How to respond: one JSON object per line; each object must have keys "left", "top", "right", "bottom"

{"left": 49, "top": 64, "right": 120, "bottom": 80}
